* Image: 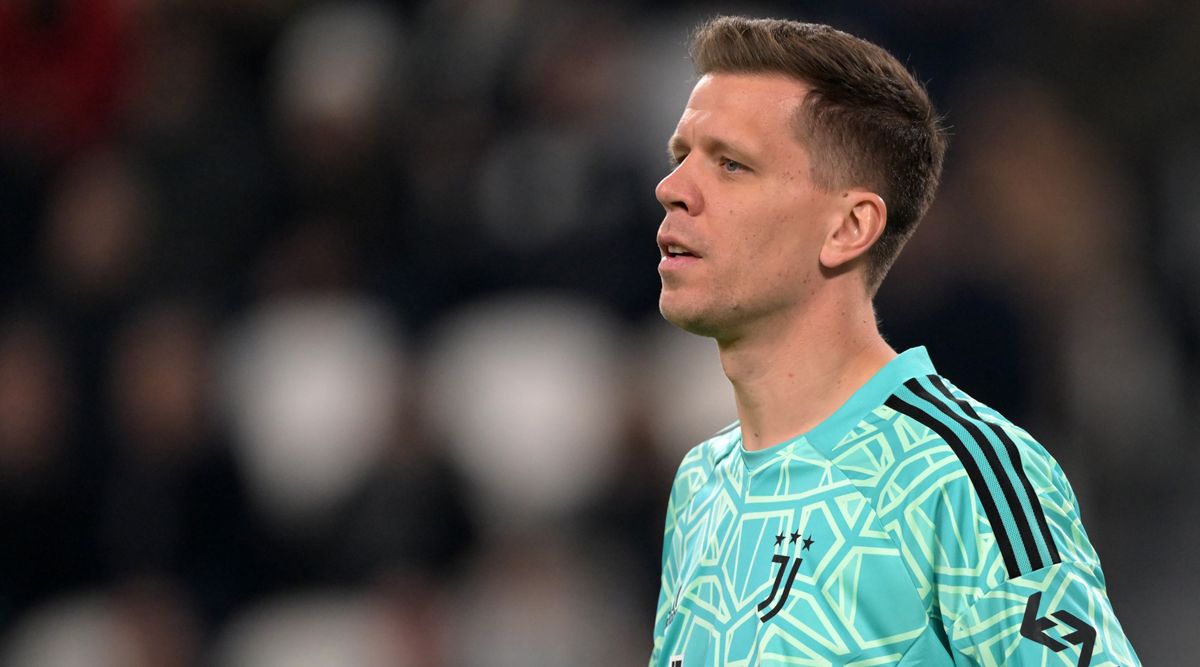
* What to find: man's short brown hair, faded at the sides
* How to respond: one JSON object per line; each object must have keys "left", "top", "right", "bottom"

{"left": 690, "top": 17, "right": 947, "bottom": 293}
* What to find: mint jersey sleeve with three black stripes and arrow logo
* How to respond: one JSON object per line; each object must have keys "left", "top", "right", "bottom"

{"left": 887, "top": 375, "right": 1140, "bottom": 667}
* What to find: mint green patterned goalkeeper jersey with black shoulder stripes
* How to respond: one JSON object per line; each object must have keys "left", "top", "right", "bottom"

{"left": 650, "top": 348, "right": 1140, "bottom": 667}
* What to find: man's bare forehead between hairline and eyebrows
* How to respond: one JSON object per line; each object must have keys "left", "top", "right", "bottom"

{"left": 676, "top": 72, "right": 809, "bottom": 145}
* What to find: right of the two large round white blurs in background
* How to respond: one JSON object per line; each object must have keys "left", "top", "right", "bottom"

{"left": 426, "top": 295, "right": 622, "bottom": 533}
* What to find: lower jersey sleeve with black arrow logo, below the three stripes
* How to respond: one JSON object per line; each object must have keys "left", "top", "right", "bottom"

{"left": 948, "top": 561, "right": 1141, "bottom": 667}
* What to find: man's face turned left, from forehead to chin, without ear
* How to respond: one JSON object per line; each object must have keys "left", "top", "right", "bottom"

{"left": 655, "top": 73, "right": 841, "bottom": 341}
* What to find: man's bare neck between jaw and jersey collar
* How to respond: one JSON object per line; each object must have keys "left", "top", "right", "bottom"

{"left": 719, "top": 281, "right": 896, "bottom": 450}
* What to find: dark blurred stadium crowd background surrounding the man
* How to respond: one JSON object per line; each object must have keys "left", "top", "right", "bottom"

{"left": 0, "top": 0, "right": 1200, "bottom": 667}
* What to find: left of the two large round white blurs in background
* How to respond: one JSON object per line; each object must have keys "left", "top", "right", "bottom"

{"left": 223, "top": 292, "right": 401, "bottom": 528}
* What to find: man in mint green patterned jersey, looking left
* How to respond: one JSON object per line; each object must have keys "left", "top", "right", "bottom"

{"left": 650, "top": 17, "right": 1139, "bottom": 667}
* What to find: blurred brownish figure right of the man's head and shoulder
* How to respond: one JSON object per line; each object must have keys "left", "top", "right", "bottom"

{"left": 959, "top": 77, "right": 1184, "bottom": 482}
